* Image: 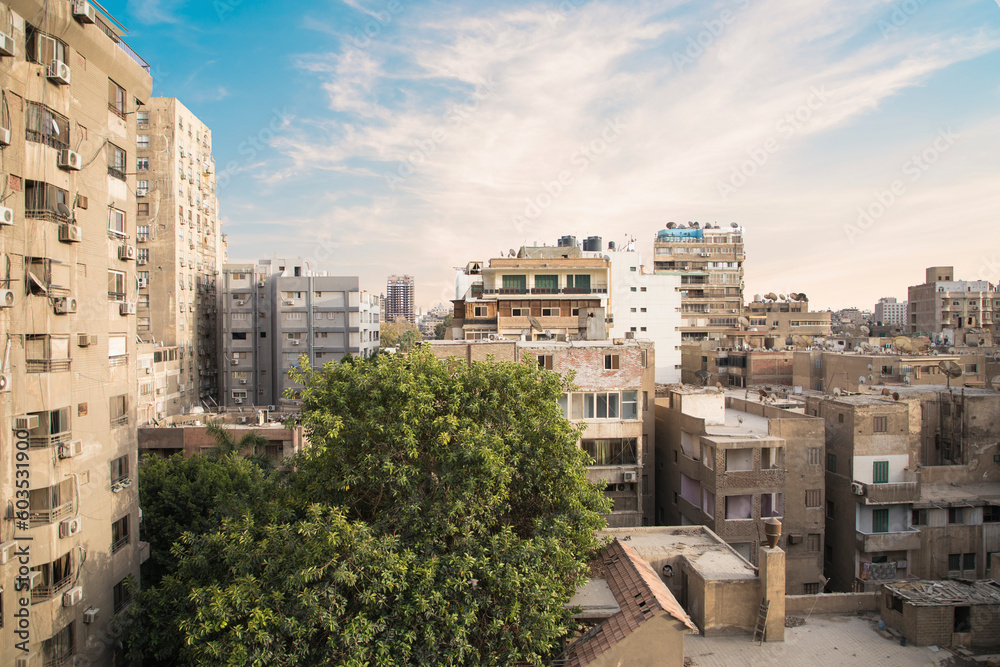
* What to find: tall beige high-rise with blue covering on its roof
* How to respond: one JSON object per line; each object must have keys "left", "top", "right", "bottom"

{"left": 653, "top": 222, "right": 746, "bottom": 342}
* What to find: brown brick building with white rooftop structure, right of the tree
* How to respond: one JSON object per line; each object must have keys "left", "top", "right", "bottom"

{"left": 655, "top": 387, "right": 825, "bottom": 595}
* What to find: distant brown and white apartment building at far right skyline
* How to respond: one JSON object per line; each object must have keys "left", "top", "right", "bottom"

{"left": 908, "top": 266, "right": 1000, "bottom": 344}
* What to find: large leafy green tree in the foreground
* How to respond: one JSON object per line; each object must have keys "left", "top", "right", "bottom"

{"left": 125, "top": 349, "right": 610, "bottom": 665}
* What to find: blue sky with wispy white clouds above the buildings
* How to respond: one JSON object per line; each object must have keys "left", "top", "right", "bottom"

{"left": 103, "top": 0, "right": 1000, "bottom": 309}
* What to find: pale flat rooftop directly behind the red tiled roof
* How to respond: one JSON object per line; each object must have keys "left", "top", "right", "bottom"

{"left": 598, "top": 526, "right": 757, "bottom": 580}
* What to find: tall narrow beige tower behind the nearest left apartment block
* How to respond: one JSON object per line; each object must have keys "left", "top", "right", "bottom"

{"left": 136, "top": 97, "right": 224, "bottom": 423}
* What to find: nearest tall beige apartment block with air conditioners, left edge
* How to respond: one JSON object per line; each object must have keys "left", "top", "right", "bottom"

{"left": 0, "top": 0, "right": 152, "bottom": 665}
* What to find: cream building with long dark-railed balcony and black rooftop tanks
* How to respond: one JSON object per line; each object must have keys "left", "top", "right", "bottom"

{"left": 452, "top": 243, "right": 610, "bottom": 340}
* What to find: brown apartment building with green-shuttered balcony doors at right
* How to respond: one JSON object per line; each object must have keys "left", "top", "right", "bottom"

{"left": 806, "top": 385, "right": 1000, "bottom": 591}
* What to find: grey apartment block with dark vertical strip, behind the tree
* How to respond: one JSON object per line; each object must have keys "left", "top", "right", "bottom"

{"left": 219, "top": 257, "right": 380, "bottom": 407}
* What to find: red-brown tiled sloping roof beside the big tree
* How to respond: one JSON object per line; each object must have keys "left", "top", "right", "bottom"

{"left": 566, "top": 539, "right": 698, "bottom": 667}
